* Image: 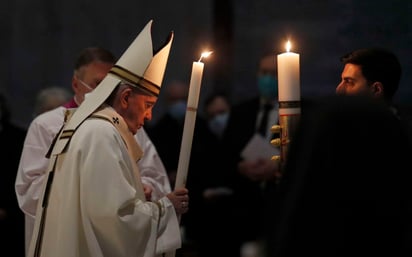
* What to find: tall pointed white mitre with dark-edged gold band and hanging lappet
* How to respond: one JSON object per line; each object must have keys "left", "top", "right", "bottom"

{"left": 52, "top": 20, "right": 174, "bottom": 154}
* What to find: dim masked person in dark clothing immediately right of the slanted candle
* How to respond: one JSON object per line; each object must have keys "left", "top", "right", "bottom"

{"left": 189, "top": 92, "right": 239, "bottom": 257}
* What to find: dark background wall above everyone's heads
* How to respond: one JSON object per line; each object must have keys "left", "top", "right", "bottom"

{"left": 0, "top": 0, "right": 412, "bottom": 126}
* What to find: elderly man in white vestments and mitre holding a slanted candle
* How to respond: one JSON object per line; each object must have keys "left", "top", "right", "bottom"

{"left": 24, "top": 21, "right": 189, "bottom": 256}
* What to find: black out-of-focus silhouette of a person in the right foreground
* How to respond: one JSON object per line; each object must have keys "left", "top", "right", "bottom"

{"left": 265, "top": 95, "right": 412, "bottom": 257}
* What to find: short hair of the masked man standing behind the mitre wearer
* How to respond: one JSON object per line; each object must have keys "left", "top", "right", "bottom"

{"left": 74, "top": 47, "right": 116, "bottom": 70}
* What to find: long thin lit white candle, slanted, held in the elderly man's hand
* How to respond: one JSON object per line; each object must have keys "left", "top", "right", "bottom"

{"left": 175, "top": 52, "right": 212, "bottom": 188}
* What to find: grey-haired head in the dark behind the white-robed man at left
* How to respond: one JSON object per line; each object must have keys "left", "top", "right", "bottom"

{"left": 33, "top": 86, "right": 72, "bottom": 117}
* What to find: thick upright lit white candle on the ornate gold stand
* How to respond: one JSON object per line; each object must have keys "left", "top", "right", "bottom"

{"left": 278, "top": 41, "right": 300, "bottom": 102}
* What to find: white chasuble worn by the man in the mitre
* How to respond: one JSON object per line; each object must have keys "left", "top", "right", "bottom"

{"left": 28, "top": 107, "right": 181, "bottom": 257}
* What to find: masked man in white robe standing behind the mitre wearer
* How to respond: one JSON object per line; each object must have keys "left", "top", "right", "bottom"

{"left": 15, "top": 47, "right": 174, "bottom": 252}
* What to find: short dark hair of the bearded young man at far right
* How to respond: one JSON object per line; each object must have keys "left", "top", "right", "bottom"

{"left": 341, "top": 48, "right": 402, "bottom": 100}
